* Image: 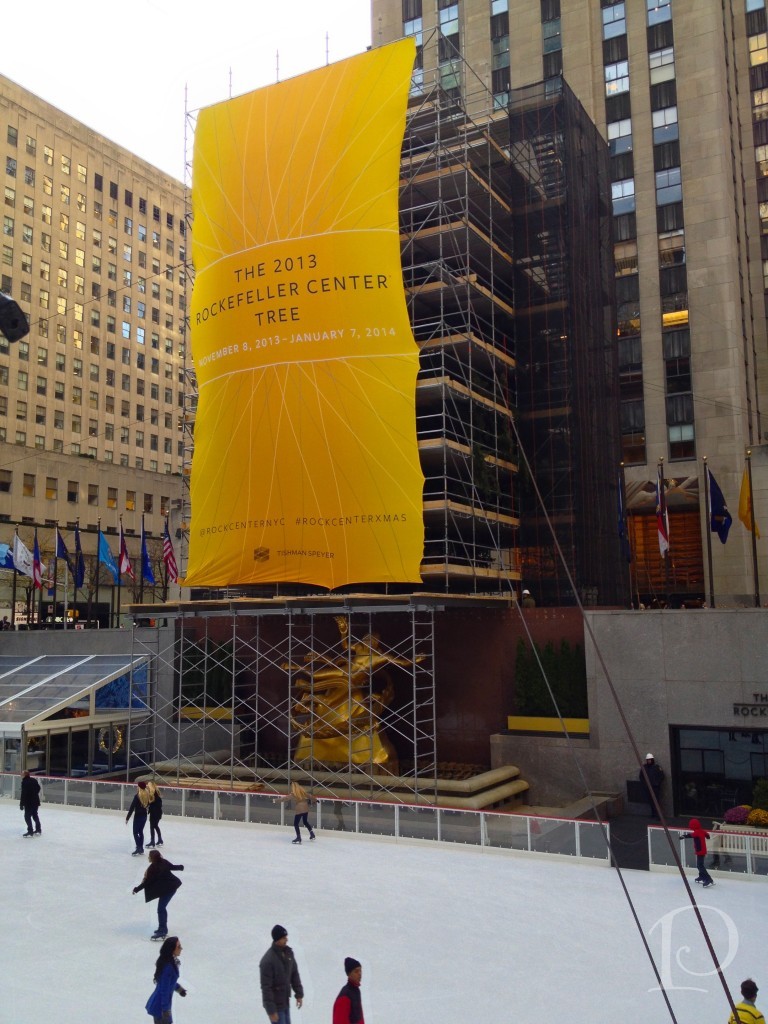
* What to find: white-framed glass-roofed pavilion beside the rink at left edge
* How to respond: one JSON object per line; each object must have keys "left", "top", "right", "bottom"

{"left": 0, "top": 654, "right": 148, "bottom": 776}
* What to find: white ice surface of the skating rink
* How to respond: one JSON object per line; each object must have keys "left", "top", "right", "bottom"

{"left": 0, "top": 801, "right": 768, "bottom": 1024}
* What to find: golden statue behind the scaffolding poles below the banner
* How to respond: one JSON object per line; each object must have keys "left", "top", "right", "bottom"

{"left": 283, "top": 615, "right": 423, "bottom": 772}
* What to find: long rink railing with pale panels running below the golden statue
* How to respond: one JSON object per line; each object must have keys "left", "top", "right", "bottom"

{"left": 0, "top": 774, "right": 609, "bottom": 865}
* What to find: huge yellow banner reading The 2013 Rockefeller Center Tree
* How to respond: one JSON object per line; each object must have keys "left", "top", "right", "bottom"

{"left": 185, "top": 40, "right": 424, "bottom": 589}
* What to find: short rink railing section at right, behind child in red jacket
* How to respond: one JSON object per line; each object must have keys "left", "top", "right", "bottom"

{"left": 648, "top": 825, "right": 768, "bottom": 879}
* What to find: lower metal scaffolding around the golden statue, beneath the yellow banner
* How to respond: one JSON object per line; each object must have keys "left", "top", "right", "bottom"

{"left": 130, "top": 598, "right": 437, "bottom": 803}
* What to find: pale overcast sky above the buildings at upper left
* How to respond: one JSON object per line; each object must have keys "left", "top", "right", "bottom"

{"left": 0, "top": 0, "right": 371, "bottom": 180}
